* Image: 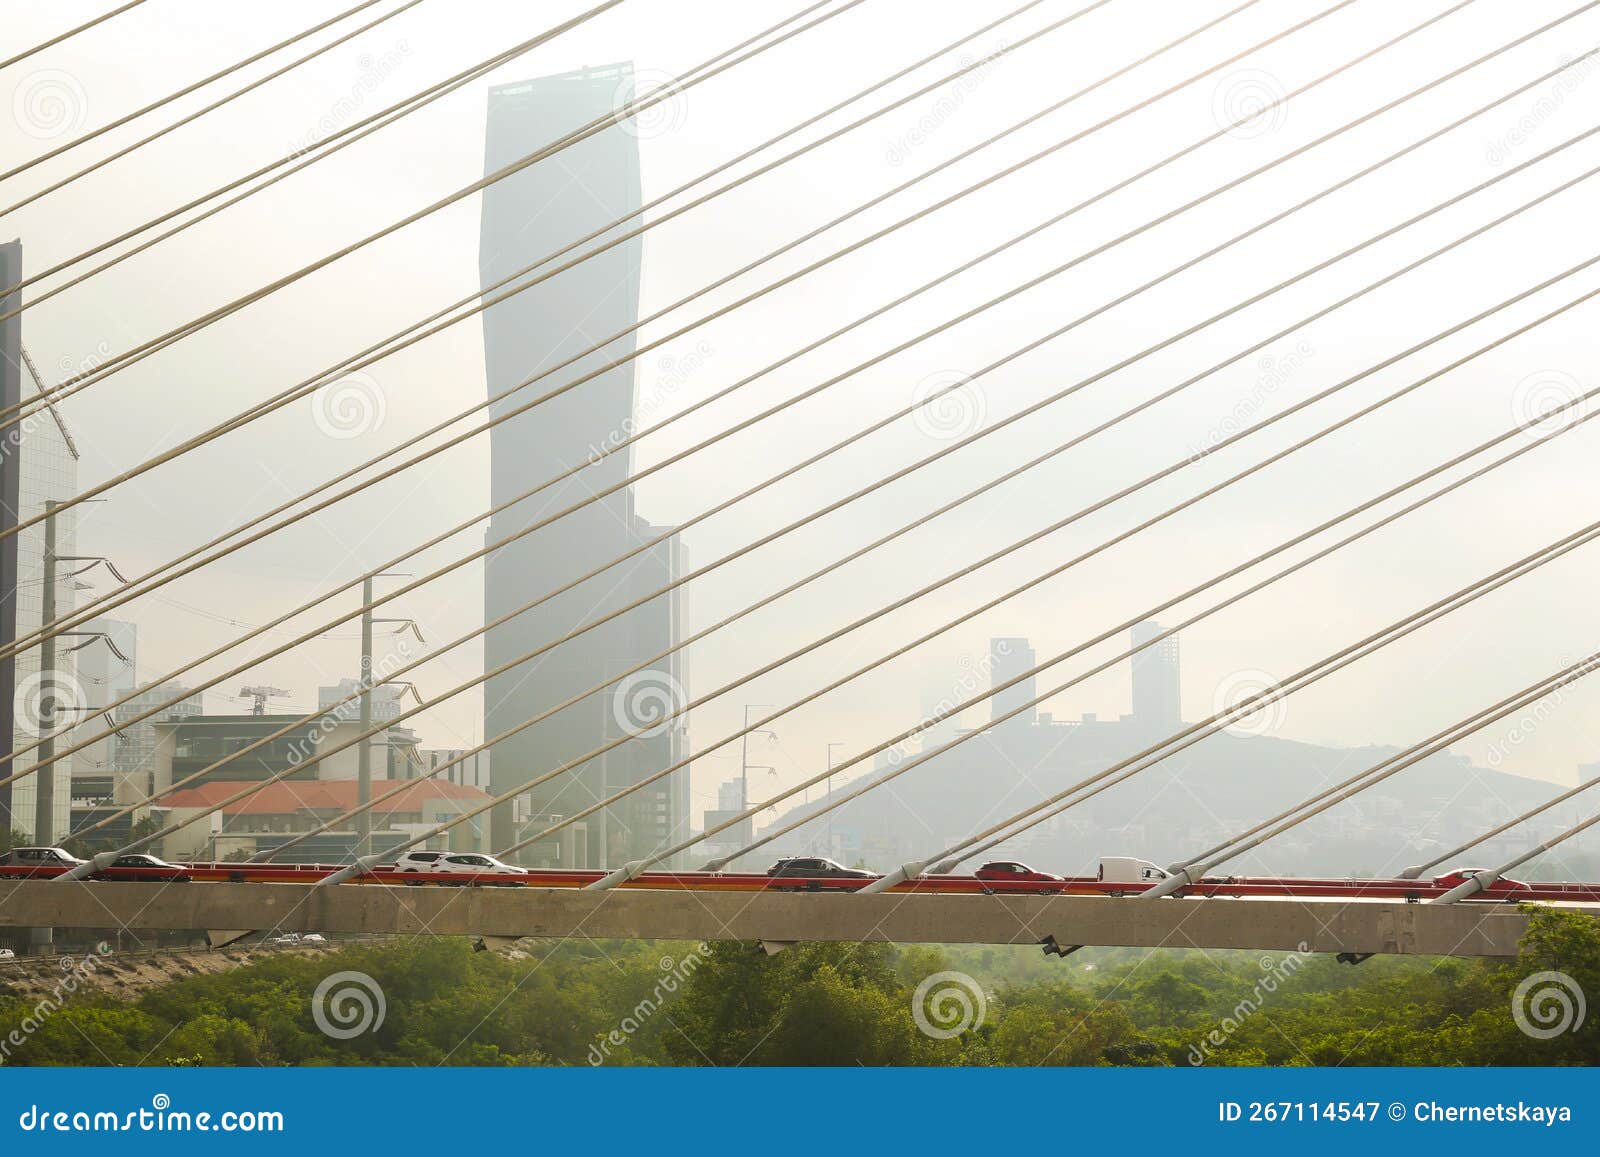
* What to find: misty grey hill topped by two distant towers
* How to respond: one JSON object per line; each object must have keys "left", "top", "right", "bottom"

{"left": 752, "top": 623, "right": 1600, "bottom": 879}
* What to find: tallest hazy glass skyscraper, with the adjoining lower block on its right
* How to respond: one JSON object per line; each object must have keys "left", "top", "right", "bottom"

{"left": 478, "top": 64, "right": 688, "bottom": 866}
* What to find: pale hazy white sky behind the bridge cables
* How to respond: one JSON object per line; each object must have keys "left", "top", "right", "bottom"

{"left": 0, "top": 0, "right": 1600, "bottom": 811}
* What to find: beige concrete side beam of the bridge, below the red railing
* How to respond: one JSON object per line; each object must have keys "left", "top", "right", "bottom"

{"left": 0, "top": 882, "right": 1561, "bottom": 955}
